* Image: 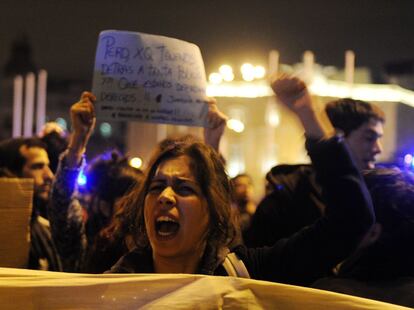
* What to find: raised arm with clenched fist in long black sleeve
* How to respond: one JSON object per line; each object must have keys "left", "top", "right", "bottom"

{"left": 246, "top": 77, "right": 375, "bottom": 285}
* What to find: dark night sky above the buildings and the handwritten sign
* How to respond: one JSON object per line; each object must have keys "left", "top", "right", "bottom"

{"left": 0, "top": 0, "right": 414, "bottom": 79}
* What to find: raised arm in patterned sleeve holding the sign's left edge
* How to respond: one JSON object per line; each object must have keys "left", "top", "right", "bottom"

{"left": 48, "top": 92, "right": 95, "bottom": 272}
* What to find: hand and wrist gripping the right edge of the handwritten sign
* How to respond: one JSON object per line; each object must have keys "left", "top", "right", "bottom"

{"left": 204, "top": 98, "right": 228, "bottom": 153}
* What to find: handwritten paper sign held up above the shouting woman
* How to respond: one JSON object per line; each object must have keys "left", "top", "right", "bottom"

{"left": 92, "top": 30, "right": 208, "bottom": 126}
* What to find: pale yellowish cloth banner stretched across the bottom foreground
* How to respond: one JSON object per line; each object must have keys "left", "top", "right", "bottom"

{"left": 0, "top": 268, "right": 408, "bottom": 310}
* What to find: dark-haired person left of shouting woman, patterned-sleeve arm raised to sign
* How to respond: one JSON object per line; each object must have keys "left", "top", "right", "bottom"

{"left": 49, "top": 93, "right": 142, "bottom": 272}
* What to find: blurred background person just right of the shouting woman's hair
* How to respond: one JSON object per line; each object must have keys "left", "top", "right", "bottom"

{"left": 231, "top": 173, "right": 256, "bottom": 232}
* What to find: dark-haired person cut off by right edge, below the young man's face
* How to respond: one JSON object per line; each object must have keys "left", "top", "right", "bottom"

{"left": 341, "top": 168, "right": 414, "bottom": 280}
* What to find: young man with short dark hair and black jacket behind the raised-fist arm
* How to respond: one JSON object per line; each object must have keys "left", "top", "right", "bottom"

{"left": 245, "top": 98, "right": 385, "bottom": 247}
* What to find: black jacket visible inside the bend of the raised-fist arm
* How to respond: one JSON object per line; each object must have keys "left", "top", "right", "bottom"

{"left": 243, "top": 164, "right": 325, "bottom": 247}
